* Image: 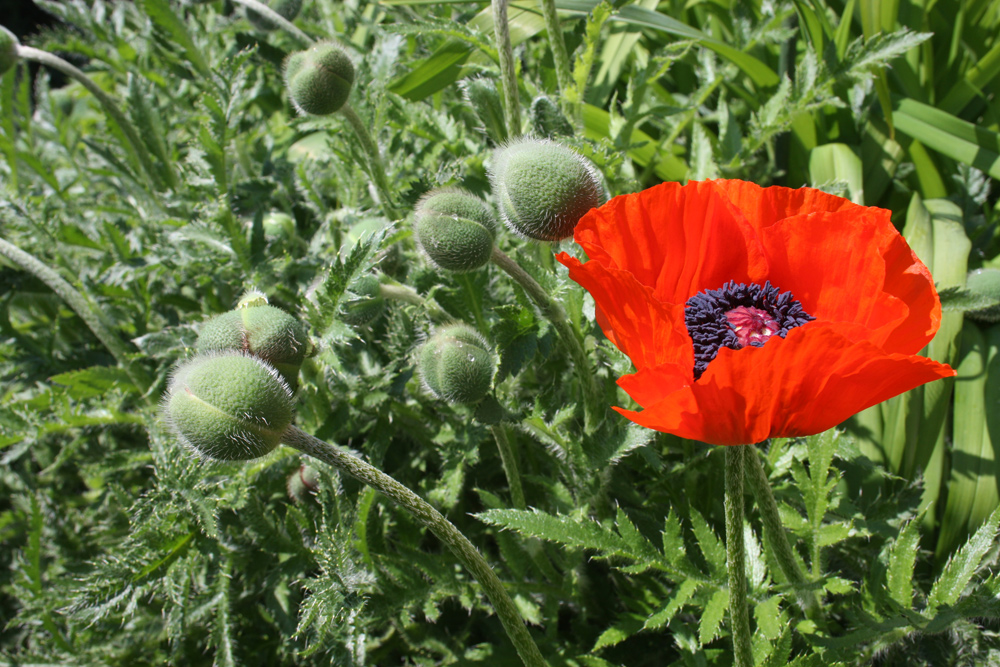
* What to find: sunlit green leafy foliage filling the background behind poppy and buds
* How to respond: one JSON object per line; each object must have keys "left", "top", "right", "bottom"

{"left": 0, "top": 0, "right": 1000, "bottom": 667}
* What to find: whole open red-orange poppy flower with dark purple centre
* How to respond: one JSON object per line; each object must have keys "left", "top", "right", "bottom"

{"left": 558, "top": 181, "right": 955, "bottom": 445}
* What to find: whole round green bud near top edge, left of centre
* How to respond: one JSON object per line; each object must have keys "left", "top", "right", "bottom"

{"left": 285, "top": 42, "right": 354, "bottom": 116}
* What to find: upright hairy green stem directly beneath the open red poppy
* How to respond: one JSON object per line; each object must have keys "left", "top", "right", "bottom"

{"left": 726, "top": 445, "right": 753, "bottom": 667}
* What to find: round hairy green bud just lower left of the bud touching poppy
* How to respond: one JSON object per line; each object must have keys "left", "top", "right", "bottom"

{"left": 413, "top": 188, "right": 497, "bottom": 272}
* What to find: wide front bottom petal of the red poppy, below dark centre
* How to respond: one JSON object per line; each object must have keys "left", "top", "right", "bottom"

{"left": 615, "top": 322, "right": 955, "bottom": 445}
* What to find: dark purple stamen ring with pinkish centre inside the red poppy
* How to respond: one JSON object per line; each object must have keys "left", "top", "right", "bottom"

{"left": 684, "top": 281, "right": 816, "bottom": 380}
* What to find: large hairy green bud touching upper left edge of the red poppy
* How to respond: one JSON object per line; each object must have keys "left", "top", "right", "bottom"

{"left": 490, "top": 139, "right": 604, "bottom": 241}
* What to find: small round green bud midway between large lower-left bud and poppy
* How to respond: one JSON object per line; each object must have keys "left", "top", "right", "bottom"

{"left": 419, "top": 324, "right": 497, "bottom": 403}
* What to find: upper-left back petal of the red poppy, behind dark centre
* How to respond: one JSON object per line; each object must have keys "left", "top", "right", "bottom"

{"left": 574, "top": 182, "right": 767, "bottom": 303}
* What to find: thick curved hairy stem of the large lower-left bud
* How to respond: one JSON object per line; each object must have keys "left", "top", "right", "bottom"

{"left": 283, "top": 426, "right": 547, "bottom": 667}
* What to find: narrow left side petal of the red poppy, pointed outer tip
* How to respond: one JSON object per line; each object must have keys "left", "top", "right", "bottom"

{"left": 556, "top": 253, "right": 694, "bottom": 377}
